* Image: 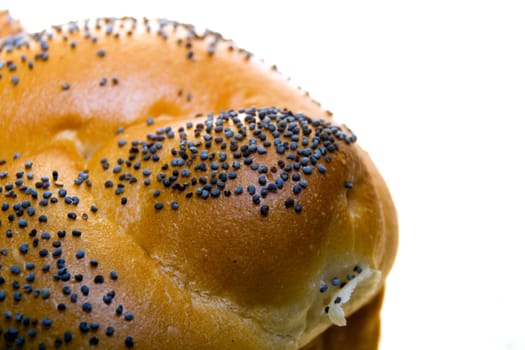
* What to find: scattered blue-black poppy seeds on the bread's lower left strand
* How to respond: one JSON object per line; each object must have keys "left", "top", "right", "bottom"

{"left": 0, "top": 158, "right": 134, "bottom": 349}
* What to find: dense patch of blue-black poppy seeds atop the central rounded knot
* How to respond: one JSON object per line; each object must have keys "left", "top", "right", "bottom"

{"left": 94, "top": 107, "right": 356, "bottom": 217}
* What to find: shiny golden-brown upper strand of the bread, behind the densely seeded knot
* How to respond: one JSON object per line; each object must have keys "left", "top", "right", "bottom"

{"left": 0, "top": 19, "right": 327, "bottom": 157}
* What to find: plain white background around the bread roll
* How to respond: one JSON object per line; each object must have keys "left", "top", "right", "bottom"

{"left": 4, "top": 0, "right": 525, "bottom": 350}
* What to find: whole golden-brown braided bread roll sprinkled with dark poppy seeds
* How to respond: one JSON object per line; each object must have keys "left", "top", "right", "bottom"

{"left": 0, "top": 18, "right": 397, "bottom": 349}
